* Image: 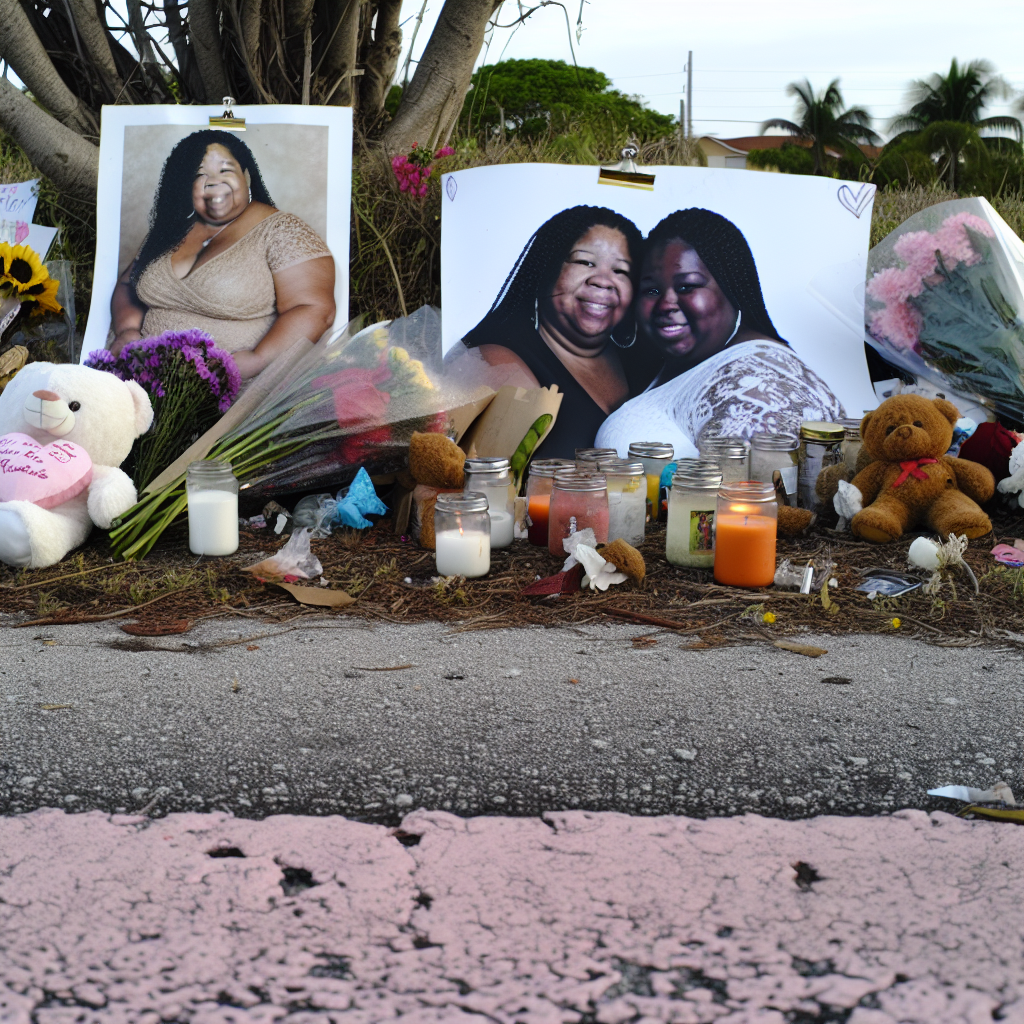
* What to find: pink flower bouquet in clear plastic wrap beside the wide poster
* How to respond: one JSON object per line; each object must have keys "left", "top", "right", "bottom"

{"left": 864, "top": 199, "right": 1024, "bottom": 421}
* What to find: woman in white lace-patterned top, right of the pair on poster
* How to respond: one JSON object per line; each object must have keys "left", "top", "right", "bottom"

{"left": 595, "top": 209, "right": 845, "bottom": 459}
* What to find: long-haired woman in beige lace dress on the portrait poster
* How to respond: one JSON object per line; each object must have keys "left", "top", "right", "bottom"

{"left": 108, "top": 130, "right": 335, "bottom": 379}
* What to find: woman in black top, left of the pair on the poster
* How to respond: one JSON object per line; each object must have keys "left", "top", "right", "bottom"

{"left": 462, "top": 206, "right": 657, "bottom": 458}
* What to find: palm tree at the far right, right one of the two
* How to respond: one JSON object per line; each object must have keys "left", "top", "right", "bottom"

{"left": 891, "top": 57, "right": 1024, "bottom": 142}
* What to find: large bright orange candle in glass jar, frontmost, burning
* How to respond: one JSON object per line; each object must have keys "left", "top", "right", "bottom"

{"left": 715, "top": 480, "right": 778, "bottom": 587}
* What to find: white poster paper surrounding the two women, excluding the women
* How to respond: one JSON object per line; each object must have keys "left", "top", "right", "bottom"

{"left": 441, "top": 164, "right": 877, "bottom": 455}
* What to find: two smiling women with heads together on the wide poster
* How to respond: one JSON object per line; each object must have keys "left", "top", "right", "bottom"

{"left": 463, "top": 205, "right": 846, "bottom": 458}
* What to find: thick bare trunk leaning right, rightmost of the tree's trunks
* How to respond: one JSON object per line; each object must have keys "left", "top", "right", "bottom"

{"left": 383, "top": 0, "right": 500, "bottom": 153}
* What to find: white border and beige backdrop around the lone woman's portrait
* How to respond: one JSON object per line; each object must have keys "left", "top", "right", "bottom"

{"left": 82, "top": 104, "right": 352, "bottom": 360}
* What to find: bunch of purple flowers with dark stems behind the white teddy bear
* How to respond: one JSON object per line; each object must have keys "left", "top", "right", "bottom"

{"left": 85, "top": 330, "right": 241, "bottom": 490}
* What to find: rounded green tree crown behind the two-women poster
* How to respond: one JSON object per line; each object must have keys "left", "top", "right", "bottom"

{"left": 460, "top": 58, "right": 678, "bottom": 141}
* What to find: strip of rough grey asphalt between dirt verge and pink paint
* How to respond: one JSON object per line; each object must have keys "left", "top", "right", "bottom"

{"left": 0, "top": 617, "right": 1024, "bottom": 824}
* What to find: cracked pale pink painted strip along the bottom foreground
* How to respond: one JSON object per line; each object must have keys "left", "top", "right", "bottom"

{"left": 0, "top": 810, "right": 1024, "bottom": 1024}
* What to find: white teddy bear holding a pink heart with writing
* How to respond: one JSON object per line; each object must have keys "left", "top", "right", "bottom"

{"left": 0, "top": 362, "right": 153, "bottom": 568}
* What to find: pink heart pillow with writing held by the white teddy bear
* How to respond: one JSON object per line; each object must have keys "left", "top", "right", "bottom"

{"left": 0, "top": 434, "right": 92, "bottom": 509}
